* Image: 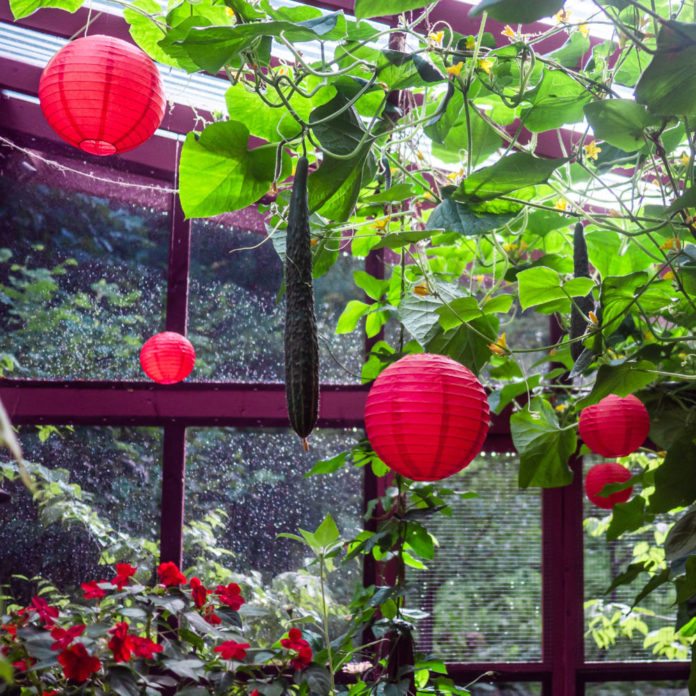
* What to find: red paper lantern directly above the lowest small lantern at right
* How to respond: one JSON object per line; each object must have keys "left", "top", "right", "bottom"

{"left": 578, "top": 394, "right": 650, "bottom": 457}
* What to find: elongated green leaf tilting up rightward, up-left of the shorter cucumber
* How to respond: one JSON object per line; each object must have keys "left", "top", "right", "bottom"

{"left": 452, "top": 152, "right": 568, "bottom": 203}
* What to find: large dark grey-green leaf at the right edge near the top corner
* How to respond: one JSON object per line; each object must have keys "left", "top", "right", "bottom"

{"left": 635, "top": 20, "right": 696, "bottom": 116}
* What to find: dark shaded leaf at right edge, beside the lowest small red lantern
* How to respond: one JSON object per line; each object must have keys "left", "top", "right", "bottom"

{"left": 648, "top": 433, "right": 696, "bottom": 513}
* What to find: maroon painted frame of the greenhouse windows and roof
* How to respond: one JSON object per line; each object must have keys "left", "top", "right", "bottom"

{"left": 0, "top": 0, "right": 689, "bottom": 696}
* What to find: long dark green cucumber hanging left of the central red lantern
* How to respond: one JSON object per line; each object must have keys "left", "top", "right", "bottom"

{"left": 285, "top": 157, "right": 319, "bottom": 450}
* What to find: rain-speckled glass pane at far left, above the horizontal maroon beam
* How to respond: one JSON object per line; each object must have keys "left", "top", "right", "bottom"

{"left": 0, "top": 150, "right": 169, "bottom": 379}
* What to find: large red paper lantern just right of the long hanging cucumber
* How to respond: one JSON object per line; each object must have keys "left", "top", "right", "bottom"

{"left": 365, "top": 353, "right": 488, "bottom": 481}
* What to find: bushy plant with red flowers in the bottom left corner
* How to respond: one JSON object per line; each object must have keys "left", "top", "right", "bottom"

{"left": 0, "top": 562, "right": 321, "bottom": 696}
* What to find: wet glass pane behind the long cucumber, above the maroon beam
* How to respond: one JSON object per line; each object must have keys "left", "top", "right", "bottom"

{"left": 189, "top": 218, "right": 363, "bottom": 384}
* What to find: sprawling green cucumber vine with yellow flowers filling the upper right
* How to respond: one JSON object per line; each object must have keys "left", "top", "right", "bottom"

{"left": 11, "top": 0, "right": 696, "bottom": 692}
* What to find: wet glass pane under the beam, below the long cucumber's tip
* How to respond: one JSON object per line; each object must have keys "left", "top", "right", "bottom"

{"left": 185, "top": 428, "right": 363, "bottom": 645}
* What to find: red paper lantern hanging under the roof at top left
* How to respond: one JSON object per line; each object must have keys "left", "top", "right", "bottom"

{"left": 39, "top": 35, "right": 166, "bottom": 155}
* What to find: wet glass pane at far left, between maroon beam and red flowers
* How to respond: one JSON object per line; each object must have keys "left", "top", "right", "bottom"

{"left": 0, "top": 426, "right": 162, "bottom": 590}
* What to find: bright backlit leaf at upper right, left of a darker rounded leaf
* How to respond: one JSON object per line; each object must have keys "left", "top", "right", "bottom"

{"left": 520, "top": 70, "right": 590, "bottom": 133}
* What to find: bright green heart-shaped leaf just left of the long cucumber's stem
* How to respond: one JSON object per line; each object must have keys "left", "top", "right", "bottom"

{"left": 179, "top": 121, "right": 290, "bottom": 217}
